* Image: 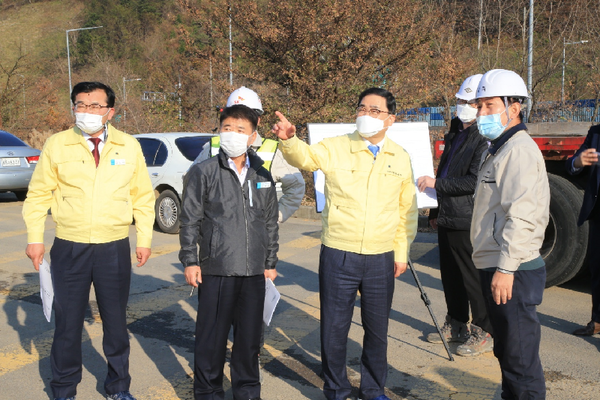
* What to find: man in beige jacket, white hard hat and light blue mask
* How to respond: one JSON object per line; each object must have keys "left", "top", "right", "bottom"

{"left": 471, "top": 69, "right": 550, "bottom": 400}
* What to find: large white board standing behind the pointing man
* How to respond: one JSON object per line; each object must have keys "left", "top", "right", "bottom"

{"left": 308, "top": 122, "right": 437, "bottom": 212}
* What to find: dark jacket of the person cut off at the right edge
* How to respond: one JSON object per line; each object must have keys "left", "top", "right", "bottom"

{"left": 567, "top": 125, "right": 600, "bottom": 226}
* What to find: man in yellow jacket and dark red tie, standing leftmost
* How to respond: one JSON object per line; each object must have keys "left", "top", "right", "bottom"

{"left": 23, "top": 82, "right": 154, "bottom": 400}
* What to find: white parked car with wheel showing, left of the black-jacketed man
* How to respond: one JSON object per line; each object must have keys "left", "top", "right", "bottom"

{"left": 134, "top": 132, "right": 215, "bottom": 233}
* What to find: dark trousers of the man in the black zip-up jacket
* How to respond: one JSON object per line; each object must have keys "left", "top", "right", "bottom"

{"left": 194, "top": 275, "right": 265, "bottom": 400}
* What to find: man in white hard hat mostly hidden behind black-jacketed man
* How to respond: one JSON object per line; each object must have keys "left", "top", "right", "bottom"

{"left": 194, "top": 86, "right": 305, "bottom": 222}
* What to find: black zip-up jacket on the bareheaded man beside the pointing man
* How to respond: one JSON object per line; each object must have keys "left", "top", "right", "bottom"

{"left": 179, "top": 150, "right": 279, "bottom": 276}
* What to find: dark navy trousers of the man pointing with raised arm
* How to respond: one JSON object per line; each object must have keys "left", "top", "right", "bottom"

{"left": 319, "top": 246, "right": 394, "bottom": 400}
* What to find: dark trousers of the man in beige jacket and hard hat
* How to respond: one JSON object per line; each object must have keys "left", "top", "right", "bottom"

{"left": 480, "top": 267, "right": 546, "bottom": 400}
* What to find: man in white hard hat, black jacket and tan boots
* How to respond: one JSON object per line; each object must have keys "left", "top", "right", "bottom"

{"left": 417, "top": 74, "right": 494, "bottom": 356}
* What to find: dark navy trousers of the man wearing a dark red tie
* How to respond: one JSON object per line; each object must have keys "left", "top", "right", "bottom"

{"left": 50, "top": 238, "right": 131, "bottom": 397}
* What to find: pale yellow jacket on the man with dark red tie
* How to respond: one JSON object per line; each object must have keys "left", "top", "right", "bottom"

{"left": 23, "top": 124, "right": 155, "bottom": 247}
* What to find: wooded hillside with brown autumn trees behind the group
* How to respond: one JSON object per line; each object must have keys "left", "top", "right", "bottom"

{"left": 0, "top": 0, "right": 600, "bottom": 147}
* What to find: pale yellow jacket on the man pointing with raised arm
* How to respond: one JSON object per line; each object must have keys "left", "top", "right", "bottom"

{"left": 280, "top": 132, "right": 418, "bottom": 263}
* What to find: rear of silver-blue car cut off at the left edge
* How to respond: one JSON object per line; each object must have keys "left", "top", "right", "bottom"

{"left": 0, "top": 130, "right": 41, "bottom": 201}
